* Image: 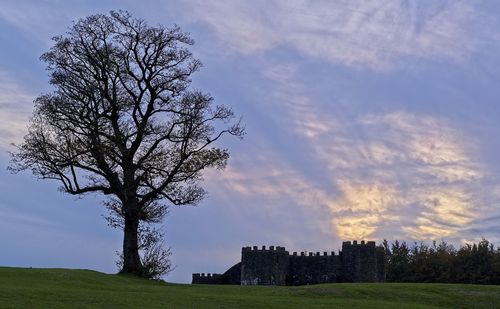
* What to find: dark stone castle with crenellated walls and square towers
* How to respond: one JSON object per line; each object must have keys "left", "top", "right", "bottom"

{"left": 192, "top": 241, "right": 385, "bottom": 285}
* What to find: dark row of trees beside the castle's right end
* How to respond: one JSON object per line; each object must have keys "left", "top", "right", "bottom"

{"left": 383, "top": 239, "right": 500, "bottom": 284}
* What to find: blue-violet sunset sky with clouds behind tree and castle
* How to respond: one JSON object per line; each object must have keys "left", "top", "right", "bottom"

{"left": 0, "top": 0, "right": 500, "bottom": 283}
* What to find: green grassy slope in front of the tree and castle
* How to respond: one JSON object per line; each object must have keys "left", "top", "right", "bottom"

{"left": 0, "top": 267, "right": 500, "bottom": 308}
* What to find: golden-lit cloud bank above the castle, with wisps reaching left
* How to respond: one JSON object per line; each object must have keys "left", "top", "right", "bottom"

{"left": 206, "top": 65, "right": 500, "bottom": 242}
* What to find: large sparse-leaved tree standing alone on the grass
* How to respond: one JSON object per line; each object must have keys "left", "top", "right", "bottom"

{"left": 7, "top": 11, "right": 244, "bottom": 276}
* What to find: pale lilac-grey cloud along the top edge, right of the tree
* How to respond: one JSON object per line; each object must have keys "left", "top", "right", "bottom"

{"left": 184, "top": 0, "right": 492, "bottom": 70}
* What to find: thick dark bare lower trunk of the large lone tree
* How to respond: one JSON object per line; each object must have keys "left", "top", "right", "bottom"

{"left": 121, "top": 216, "right": 143, "bottom": 276}
